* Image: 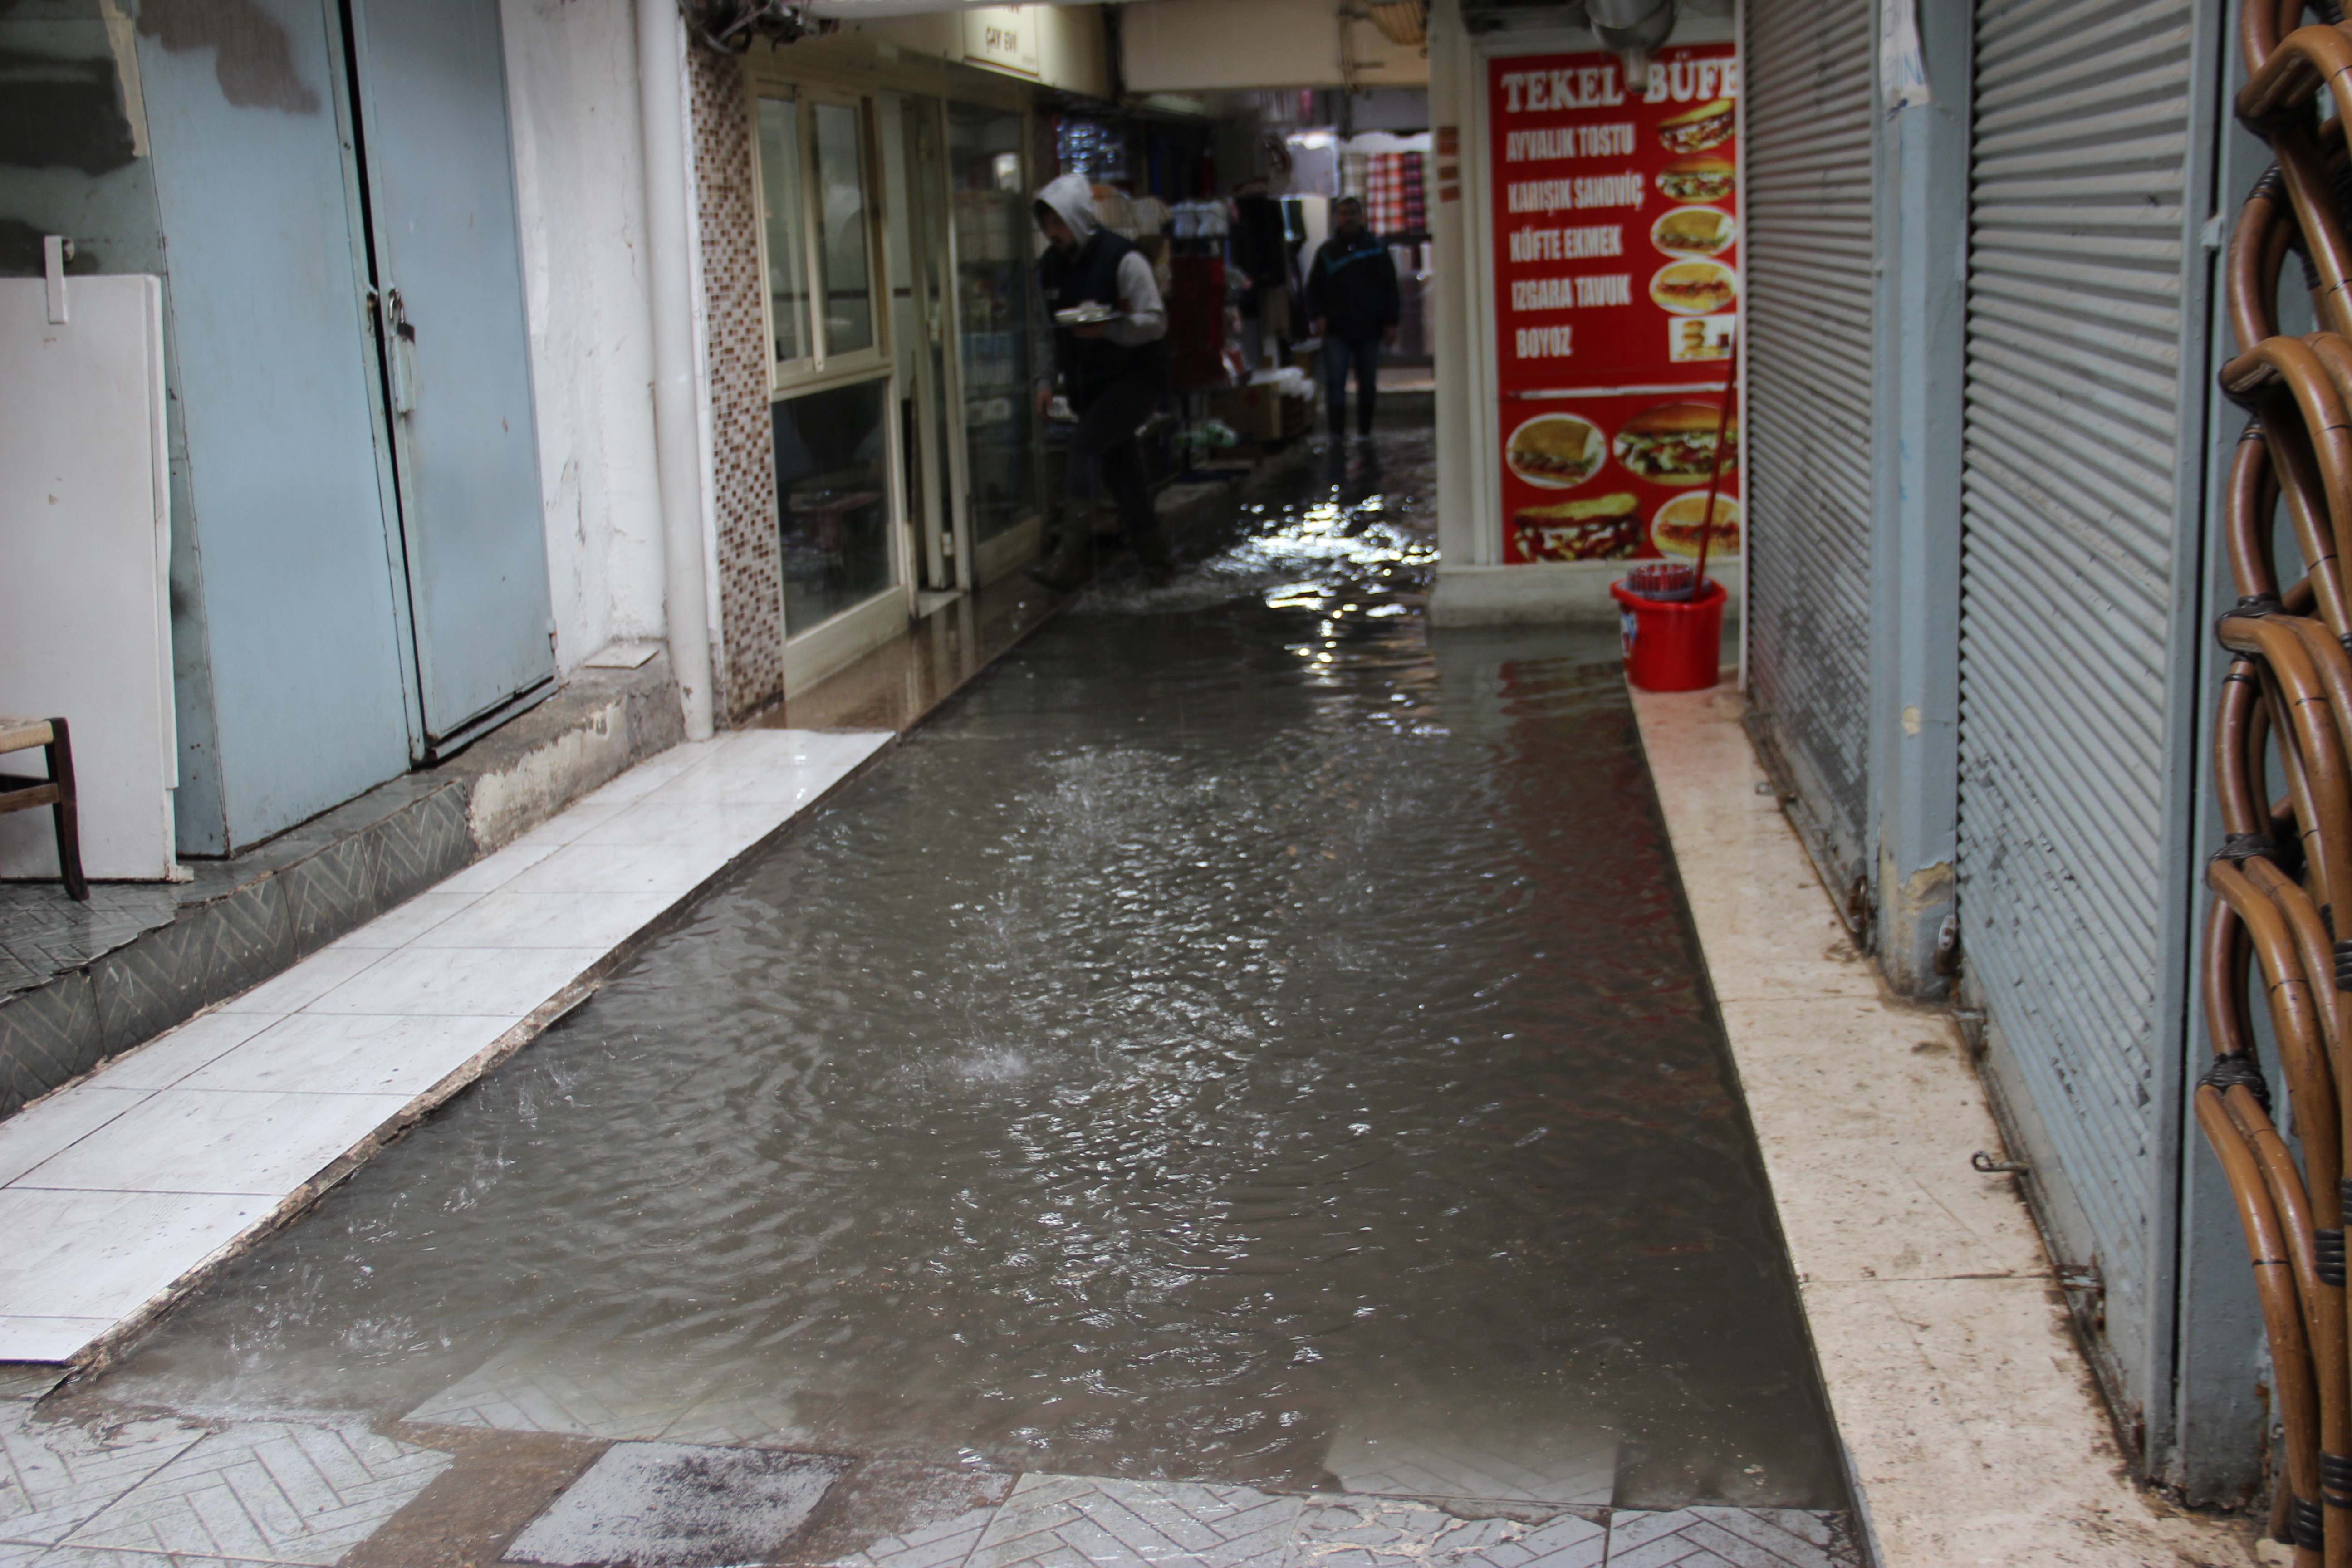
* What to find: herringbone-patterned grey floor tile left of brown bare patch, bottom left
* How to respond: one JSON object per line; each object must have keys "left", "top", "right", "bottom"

{"left": 66, "top": 1422, "right": 449, "bottom": 1568}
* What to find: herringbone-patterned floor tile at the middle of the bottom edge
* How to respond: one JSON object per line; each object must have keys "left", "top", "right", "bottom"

{"left": 971, "top": 1474, "right": 1305, "bottom": 1568}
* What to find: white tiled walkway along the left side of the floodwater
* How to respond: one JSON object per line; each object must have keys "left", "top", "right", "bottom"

{"left": 0, "top": 731, "right": 892, "bottom": 1361}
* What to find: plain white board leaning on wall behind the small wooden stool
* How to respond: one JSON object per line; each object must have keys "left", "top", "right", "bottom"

{"left": 0, "top": 275, "right": 179, "bottom": 882}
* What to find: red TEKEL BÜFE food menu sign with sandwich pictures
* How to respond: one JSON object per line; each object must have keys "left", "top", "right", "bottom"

{"left": 1486, "top": 44, "right": 1740, "bottom": 562}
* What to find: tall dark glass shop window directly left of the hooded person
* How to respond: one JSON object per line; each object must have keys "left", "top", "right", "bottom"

{"left": 948, "top": 103, "right": 1037, "bottom": 541}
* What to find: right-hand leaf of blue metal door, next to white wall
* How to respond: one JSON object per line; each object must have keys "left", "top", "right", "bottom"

{"left": 350, "top": 0, "right": 555, "bottom": 755}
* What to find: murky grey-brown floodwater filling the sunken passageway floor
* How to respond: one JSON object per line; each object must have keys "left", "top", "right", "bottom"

{"left": 106, "top": 432, "right": 1842, "bottom": 1507}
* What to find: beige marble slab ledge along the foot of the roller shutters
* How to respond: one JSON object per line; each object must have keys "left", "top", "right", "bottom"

{"left": 1611, "top": 668, "right": 2251, "bottom": 1568}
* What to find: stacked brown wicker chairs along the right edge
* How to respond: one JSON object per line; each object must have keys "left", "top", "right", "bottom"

{"left": 2197, "top": 0, "right": 2352, "bottom": 1568}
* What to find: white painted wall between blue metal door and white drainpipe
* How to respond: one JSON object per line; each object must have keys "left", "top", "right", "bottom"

{"left": 499, "top": 0, "right": 663, "bottom": 672}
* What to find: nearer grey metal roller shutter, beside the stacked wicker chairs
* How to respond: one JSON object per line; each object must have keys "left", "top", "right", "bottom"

{"left": 1959, "top": 0, "right": 2195, "bottom": 1408}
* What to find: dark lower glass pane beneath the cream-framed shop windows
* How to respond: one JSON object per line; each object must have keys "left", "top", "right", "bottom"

{"left": 774, "top": 376, "right": 892, "bottom": 637}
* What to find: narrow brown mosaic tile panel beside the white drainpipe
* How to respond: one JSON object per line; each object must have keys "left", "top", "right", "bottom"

{"left": 689, "top": 49, "right": 783, "bottom": 720}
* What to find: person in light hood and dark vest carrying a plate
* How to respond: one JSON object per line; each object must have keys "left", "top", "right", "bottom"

{"left": 1030, "top": 174, "right": 1171, "bottom": 588}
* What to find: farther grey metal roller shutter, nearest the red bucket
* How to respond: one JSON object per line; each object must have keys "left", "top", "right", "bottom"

{"left": 1745, "top": 0, "right": 1877, "bottom": 907}
